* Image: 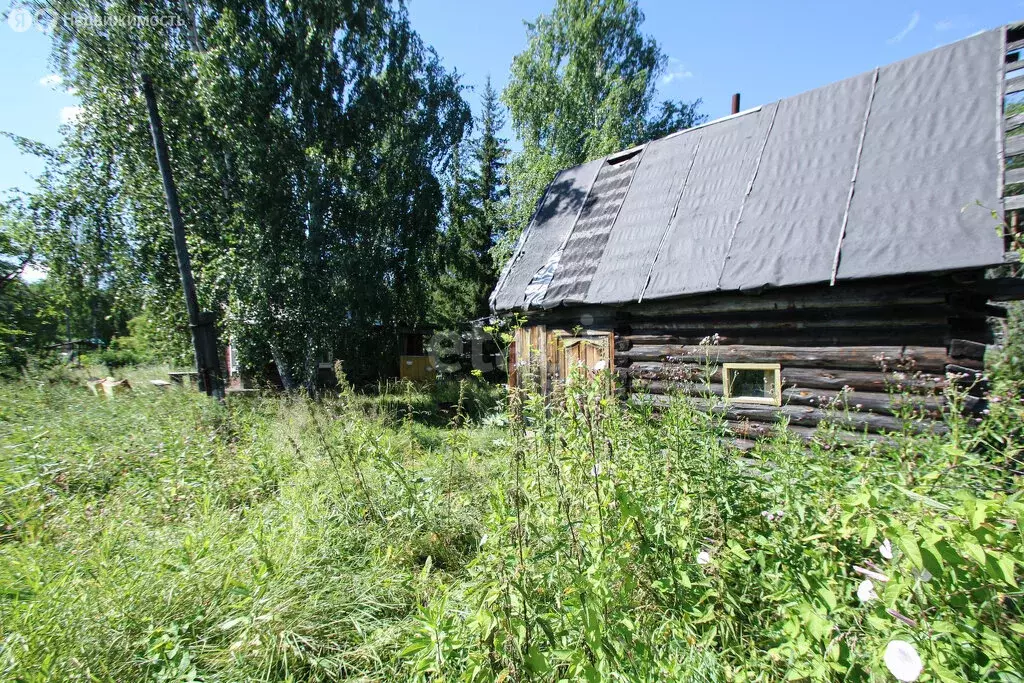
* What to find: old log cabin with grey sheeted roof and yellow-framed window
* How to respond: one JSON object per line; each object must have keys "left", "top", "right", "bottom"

{"left": 490, "top": 26, "right": 1024, "bottom": 438}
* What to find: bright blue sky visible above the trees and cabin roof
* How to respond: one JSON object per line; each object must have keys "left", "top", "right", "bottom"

{"left": 0, "top": 0, "right": 1024, "bottom": 196}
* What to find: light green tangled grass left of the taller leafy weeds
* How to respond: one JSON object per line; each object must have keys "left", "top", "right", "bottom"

{"left": 0, "top": 375, "right": 500, "bottom": 681}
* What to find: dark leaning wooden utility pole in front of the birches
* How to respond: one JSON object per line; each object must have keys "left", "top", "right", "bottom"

{"left": 142, "top": 74, "right": 224, "bottom": 399}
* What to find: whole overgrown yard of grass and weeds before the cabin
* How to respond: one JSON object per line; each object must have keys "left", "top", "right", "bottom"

{"left": 0, "top": 366, "right": 1024, "bottom": 681}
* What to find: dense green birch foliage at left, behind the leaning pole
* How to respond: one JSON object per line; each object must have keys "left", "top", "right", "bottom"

{"left": 22, "top": 0, "right": 469, "bottom": 386}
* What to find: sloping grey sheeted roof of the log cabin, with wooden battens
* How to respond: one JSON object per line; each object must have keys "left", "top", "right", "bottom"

{"left": 490, "top": 29, "right": 1006, "bottom": 311}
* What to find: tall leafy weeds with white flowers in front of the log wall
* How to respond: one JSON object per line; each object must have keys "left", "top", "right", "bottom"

{"left": 412, "top": 376, "right": 1024, "bottom": 681}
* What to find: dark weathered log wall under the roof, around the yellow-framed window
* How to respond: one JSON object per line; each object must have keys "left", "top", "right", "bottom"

{"left": 512, "top": 273, "right": 1005, "bottom": 439}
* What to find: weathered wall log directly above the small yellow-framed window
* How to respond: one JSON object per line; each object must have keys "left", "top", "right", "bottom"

{"left": 606, "top": 344, "right": 949, "bottom": 372}
